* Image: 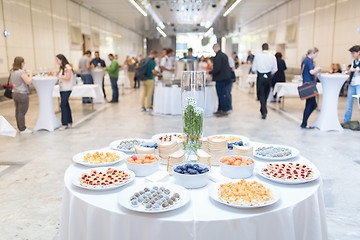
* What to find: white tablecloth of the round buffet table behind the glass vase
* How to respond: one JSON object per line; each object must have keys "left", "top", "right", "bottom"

{"left": 154, "top": 83, "right": 218, "bottom": 115}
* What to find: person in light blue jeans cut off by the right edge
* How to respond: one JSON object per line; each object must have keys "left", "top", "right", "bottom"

{"left": 344, "top": 45, "right": 360, "bottom": 124}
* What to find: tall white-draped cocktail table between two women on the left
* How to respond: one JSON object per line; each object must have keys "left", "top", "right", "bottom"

{"left": 32, "top": 77, "right": 60, "bottom": 131}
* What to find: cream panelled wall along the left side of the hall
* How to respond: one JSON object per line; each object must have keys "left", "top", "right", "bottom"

{"left": 0, "top": 0, "right": 143, "bottom": 77}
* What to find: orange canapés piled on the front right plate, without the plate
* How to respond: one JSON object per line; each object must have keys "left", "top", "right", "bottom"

{"left": 217, "top": 179, "right": 274, "bottom": 206}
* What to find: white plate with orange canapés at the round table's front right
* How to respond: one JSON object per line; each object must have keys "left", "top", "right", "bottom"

{"left": 210, "top": 179, "right": 280, "bottom": 208}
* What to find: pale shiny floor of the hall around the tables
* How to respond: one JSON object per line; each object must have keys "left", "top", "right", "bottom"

{"left": 0, "top": 83, "right": 360, "bottom": 240}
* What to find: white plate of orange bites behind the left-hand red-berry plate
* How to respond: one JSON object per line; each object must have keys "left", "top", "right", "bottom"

{"left": 73, "top": 149, "right": 126, "bottom": 167}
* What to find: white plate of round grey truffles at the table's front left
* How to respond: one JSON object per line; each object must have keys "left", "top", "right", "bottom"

{"left": 118, "top": 184, "right": 190, "bottom": 213}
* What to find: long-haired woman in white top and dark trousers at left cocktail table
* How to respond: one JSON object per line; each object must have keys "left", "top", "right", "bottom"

{"left": 56, "top": 54, "right": 74, "bottom": 130}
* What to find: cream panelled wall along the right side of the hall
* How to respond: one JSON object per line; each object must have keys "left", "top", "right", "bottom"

{"left": 232, "top": 0, "right": 360, "bottom": 69}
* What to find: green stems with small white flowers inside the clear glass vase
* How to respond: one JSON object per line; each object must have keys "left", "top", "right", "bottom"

{"left": 183, "top": 97, "right": 204, "bottom": 156}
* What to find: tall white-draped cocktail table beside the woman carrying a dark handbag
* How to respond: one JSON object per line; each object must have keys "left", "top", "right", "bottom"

{"left": 314, "top": 74, "right": 349, "bottom": 131}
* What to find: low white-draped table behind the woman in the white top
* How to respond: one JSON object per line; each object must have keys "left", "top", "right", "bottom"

{"left": 52, "top": 84, "right": 105, "bottom": 103}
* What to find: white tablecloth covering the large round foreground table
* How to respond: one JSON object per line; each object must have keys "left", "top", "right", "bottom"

{"left": 60, "top": 142, "right": 327, "bottom": 240}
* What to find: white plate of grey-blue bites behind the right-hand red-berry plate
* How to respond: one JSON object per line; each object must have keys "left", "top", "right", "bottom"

{"left": 254, "top": 145, "right": 300, "bottom": 161}
